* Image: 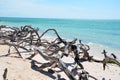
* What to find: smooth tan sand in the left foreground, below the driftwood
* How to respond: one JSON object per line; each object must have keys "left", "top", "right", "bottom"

{"left": 0, "top": 45, "right": 52, "bottom": 80}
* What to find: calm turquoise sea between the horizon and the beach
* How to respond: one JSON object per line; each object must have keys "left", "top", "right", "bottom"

{"left": 0, "top": 17, "right": 120, "bottom": 50}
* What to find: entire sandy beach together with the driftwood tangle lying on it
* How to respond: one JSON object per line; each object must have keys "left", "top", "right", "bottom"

{"left": 0, "top": 26, "right": 120, "bottom": 80}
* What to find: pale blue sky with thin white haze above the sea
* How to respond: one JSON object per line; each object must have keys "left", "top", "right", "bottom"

{"left": 0, "top": 0, "right": 120, "bottom": 19}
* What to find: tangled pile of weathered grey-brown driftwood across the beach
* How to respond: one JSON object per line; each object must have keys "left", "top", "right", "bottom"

{"left": 0, "top": 25, "right": 120, "bottom": 80}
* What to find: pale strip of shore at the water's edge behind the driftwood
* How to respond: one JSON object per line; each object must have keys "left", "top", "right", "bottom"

{"left": 44, "top": 35, "right": 120, "bottom": 60}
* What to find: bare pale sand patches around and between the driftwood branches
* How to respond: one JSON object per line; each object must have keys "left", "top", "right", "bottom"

{"left": 0, "top": 42, "right": 120, "bottom": 80}
